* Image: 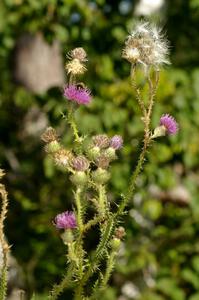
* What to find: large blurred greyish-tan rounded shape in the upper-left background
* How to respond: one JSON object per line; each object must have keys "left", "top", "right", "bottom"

{"left": 14, "top": 33, "right": 64, "bottom": 94}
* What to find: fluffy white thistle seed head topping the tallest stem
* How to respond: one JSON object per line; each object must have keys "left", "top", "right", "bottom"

{"left": 122, "top": 22, "right": 169, "bottom": 69}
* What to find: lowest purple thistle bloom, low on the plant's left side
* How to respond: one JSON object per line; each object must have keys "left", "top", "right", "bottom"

{"left": 54, "top": 211, "right": 77, "bottom": 229}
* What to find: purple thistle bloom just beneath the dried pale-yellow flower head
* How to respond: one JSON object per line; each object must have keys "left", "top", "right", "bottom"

{"left": 64, "top": 84, "right": 91, "bottom": 105}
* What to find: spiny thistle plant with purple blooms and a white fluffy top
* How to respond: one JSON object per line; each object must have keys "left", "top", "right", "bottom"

{"left": 42, "top": 22, "right": 178, "bottom": 300}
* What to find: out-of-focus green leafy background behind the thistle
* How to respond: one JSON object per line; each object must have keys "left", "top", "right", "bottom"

{"left": 0, "top": 0, "right": 199, "bottom": 300}
